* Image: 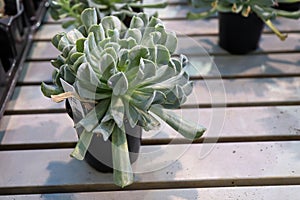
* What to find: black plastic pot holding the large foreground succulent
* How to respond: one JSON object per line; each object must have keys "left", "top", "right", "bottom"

{"left": 66, "top": 101, "right": 142, "bottom": 172}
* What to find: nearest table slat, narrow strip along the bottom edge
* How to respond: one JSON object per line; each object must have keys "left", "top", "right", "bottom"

{"left": 0, "top": 185, "right": 300, "bottom": 200}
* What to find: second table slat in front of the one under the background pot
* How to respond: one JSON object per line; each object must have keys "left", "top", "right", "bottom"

{"left": 7, "top": 77, "right": 300, "bottom": 111}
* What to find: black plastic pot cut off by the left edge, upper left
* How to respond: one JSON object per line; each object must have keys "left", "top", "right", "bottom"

{"left": 0, "top": 5, "right": 30, "bottom": 72}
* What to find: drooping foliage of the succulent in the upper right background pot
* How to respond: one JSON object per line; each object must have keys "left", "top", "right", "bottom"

{"left": 187, "top": 0, "right": 300, "bottom": 40}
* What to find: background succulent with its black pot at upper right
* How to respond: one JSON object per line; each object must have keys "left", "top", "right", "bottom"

{"left": 187, "top": 0, "right": 300, "bottom": 54}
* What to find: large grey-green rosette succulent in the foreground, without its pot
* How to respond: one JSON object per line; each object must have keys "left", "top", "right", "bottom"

{"left": 41, "top": 8, "right": 205, "bottom": 187}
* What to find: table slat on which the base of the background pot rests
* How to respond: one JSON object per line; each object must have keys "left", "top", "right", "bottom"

{"left": 27, "top": 33, "right": 300, "bottom": 61}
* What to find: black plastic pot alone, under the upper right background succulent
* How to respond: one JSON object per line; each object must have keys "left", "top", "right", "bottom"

{"left": 218, "top": 12, "right": 264, "bottom": 54}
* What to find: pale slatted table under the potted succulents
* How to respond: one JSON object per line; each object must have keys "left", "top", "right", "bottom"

{"left": 0, "top": 0, "right": 300, "bottom": 200}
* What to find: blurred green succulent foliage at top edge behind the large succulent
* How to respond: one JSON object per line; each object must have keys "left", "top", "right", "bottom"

{"left": 50, "top": 0, "right": 167, "bottom": 28}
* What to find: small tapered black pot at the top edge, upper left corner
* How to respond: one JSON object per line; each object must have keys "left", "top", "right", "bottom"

{"left": 23, "top": 0, "right": 49, "bottom": 28}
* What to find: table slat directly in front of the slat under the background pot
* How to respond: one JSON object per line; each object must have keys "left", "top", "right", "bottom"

{"left": 18, "top": 53, "right": 300, "bottom": 84}
